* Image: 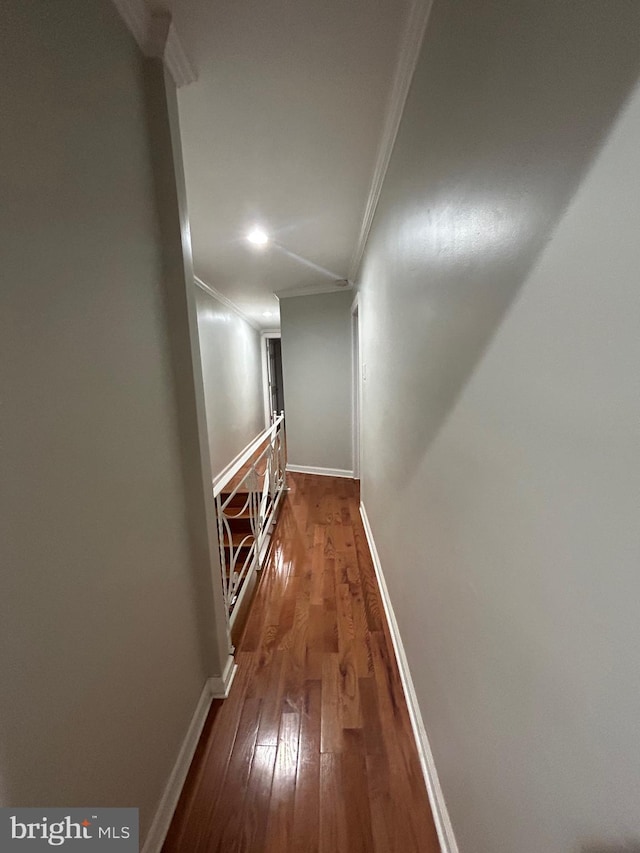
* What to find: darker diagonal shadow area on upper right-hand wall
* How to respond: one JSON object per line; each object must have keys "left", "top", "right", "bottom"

{"left": 362, "top": 0, "right": 640, "bottom": 490}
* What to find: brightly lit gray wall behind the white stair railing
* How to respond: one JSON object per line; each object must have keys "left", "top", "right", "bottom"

{"left": 194, "top": 285, "right": 264, "bottom": 477}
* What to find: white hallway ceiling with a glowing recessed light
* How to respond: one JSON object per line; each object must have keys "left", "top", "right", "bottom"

{"left": 156, "top": 0, "right": 415, "bottom": 328}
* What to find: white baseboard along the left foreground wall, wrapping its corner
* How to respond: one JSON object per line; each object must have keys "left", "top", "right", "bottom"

{"left": 142, "top": 656, "right": 238, "bottom": 853}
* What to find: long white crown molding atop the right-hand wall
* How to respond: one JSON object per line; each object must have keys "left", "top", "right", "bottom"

{"left": 349, "top": 0, "right": 433, "bottom": 281}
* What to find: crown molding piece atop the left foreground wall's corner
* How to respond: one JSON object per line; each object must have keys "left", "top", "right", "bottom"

{"left": 113, "top": 0, "right": 198, "bottom": 87}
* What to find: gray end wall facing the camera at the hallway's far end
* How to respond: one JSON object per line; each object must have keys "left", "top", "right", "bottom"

{"left": 280, "top": 291, "right": 354, "bottom": 471}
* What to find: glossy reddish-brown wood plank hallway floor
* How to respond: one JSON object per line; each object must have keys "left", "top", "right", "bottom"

{"left": 163, "top": 474, "right": 440, "bottom": 853}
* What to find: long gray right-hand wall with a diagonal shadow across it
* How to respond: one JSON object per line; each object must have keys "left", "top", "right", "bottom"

{"left": 360, "top": 2, "right": 640, "bottom": 853}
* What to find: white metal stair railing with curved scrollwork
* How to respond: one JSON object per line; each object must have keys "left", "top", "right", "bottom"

{"left": 213, "top": 412, "right": 286, "bottom": 627}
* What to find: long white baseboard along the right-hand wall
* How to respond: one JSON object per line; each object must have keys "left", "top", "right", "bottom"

{"left": 360, "top": 503, "right": 458, "bottom": 853}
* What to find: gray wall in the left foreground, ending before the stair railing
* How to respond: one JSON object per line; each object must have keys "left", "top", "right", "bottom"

{"left": 0, "top": 0, "right": 225, "bottom": 837}
